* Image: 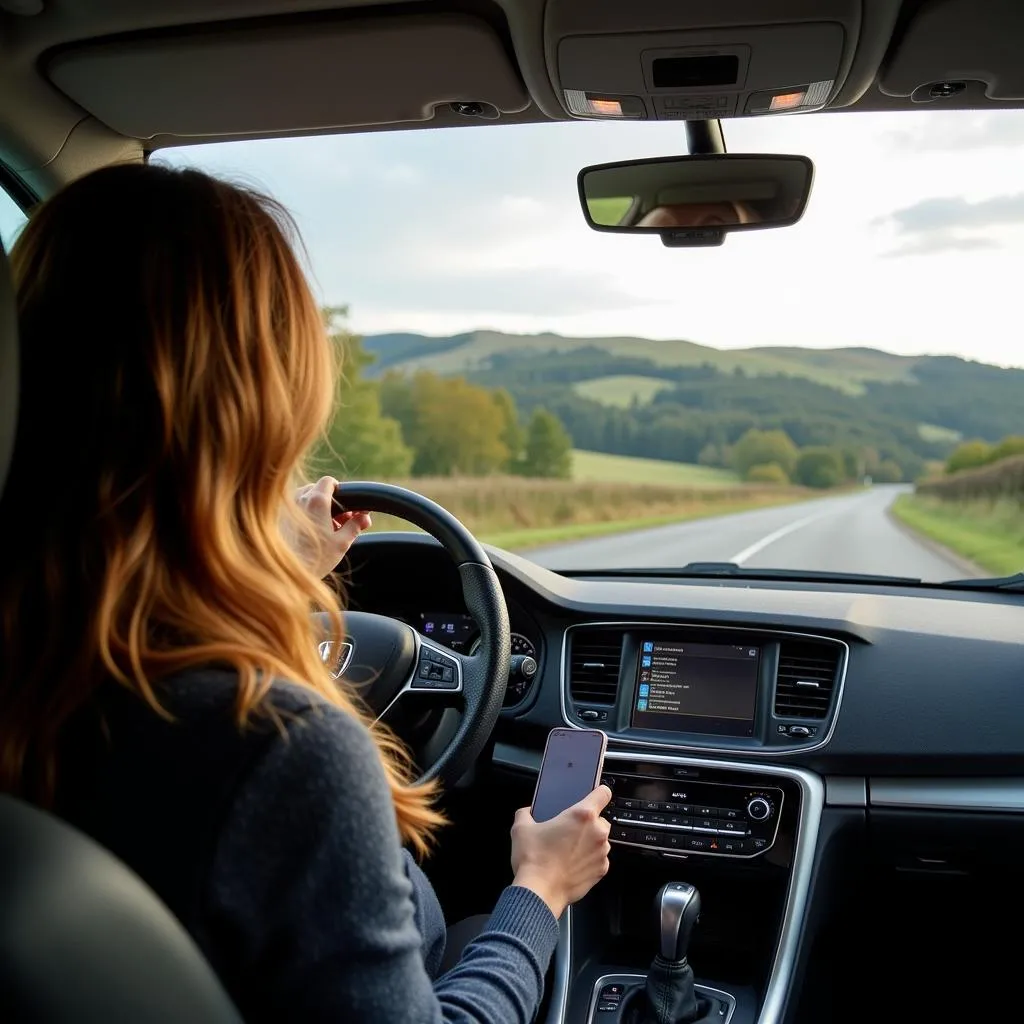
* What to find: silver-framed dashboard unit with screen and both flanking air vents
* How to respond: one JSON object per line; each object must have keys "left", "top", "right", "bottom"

{"left": 562, "top": 623, "right": 849, "bottom": 754}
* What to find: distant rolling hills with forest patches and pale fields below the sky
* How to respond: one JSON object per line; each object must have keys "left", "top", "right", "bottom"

{"left": 366, "top": 331, "right": 1024, "bottom": 479}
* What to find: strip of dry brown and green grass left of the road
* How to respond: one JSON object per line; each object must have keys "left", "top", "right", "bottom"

{"left": 364, "top": 476, "right": 814, "bottom": 551}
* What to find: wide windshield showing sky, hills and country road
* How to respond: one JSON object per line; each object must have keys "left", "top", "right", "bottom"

{"left": 155, "top": 112, "right": 1024, "bottom": 581}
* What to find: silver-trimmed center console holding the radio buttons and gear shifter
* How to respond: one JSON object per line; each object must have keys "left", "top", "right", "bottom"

{"left": 549, "top": 749, "right": 823, "bottom": 1024}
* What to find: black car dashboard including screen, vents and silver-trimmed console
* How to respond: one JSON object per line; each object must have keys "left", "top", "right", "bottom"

{"left": 346, "top": 534, "right": 1024, "bottom": 1024}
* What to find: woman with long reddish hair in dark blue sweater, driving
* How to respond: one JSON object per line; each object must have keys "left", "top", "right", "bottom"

{"left": 0, "top": 166, "right": 610, "bottom": 1022}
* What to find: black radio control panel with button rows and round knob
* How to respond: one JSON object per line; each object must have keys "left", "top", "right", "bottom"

{"left": 601, "top": 770, "right": 785, "bottom": 858}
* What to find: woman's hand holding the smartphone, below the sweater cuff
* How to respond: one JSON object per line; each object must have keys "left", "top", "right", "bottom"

{"left": 512, "top": 785, "right": 611, "bottom": 918}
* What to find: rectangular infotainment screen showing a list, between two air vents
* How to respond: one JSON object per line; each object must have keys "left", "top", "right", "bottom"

{"left": 633, "top": 637, "right": 761, "bottom": 736}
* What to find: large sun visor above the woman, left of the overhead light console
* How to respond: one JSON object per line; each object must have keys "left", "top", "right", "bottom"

{"left": 45, "top": 15, "right": 529, "bottom": 139}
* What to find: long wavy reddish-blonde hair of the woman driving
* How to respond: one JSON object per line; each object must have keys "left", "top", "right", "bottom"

{"left": 0, "top": 165, "right": 442, "bottom": 852}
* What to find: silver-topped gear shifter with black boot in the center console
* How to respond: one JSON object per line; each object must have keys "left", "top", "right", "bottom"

{"left": 625, "top": 882, "right": 724, "bottom": 1024}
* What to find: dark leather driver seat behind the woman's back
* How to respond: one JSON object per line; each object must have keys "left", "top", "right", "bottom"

{"left": 0, "top": 234, "right": 242, "bottom": 1024}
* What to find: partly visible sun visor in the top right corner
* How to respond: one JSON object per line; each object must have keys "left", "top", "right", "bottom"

{"left": 879, "top": 0, "right": 1024, "bottom": 103}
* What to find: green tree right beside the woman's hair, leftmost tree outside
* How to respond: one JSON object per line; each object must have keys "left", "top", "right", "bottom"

{"left": 310, "top": 307, "right": 413, "bottom": 478}
